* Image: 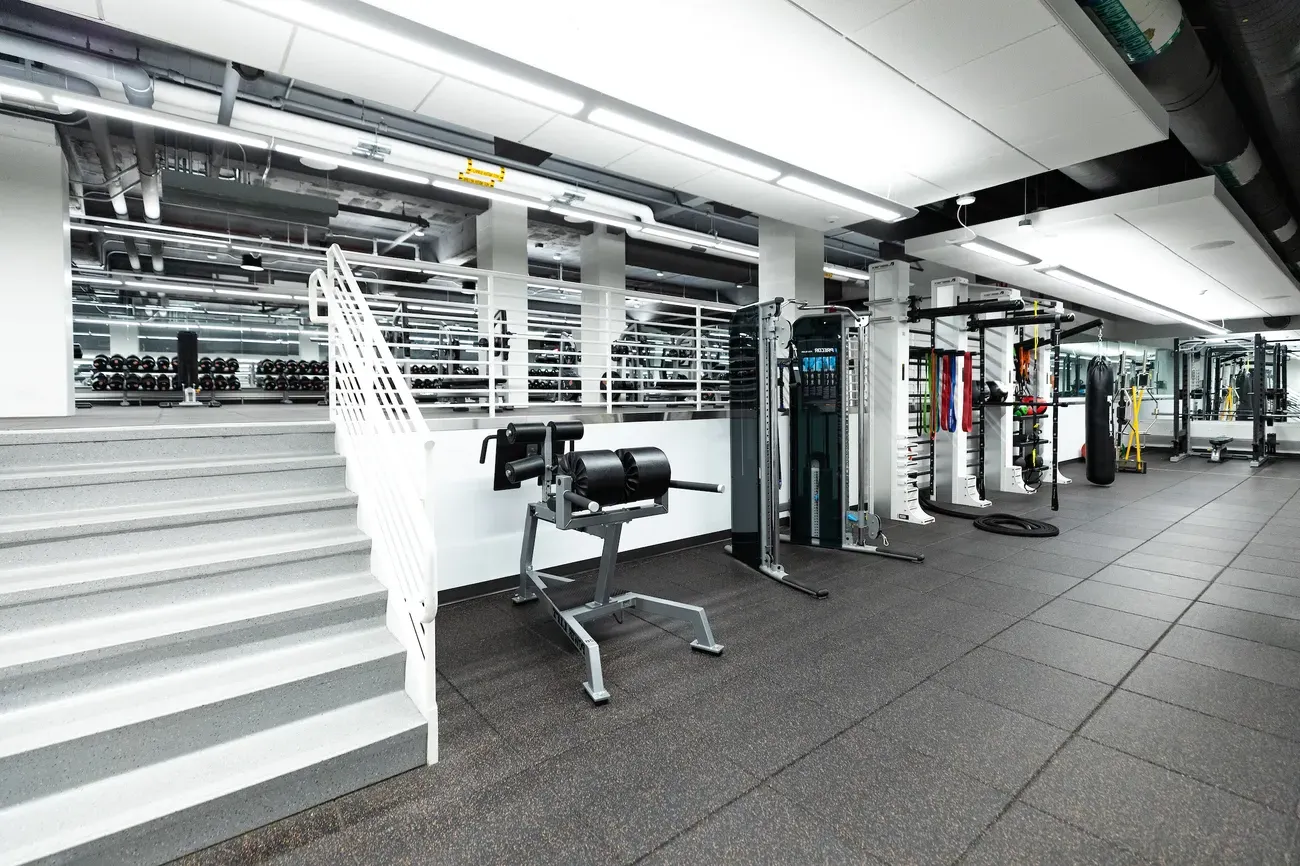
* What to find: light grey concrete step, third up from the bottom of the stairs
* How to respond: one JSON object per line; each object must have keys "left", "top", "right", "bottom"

{"left": 0, "top": 573, "right": 387, "bottom": 696}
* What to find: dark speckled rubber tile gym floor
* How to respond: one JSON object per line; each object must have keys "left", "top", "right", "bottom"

{"left": 183, "top": 458, "right": 1300, "bottom": 866}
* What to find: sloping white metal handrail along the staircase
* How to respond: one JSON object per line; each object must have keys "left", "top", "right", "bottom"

{"left": 308, "top": 246, "right": 438, "bottom": 647}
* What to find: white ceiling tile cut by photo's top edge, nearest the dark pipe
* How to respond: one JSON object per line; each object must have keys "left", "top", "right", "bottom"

{"left": 850, "top": 0, "right": 1057, "bottom": 82}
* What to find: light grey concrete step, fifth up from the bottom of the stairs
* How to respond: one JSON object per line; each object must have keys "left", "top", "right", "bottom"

{"left": 0, "top": 490, "right": 356, "bottom": 568}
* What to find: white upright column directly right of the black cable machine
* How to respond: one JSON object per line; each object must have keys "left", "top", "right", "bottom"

{"left": 867, "top": 261, "right": 935, "bottom": 523}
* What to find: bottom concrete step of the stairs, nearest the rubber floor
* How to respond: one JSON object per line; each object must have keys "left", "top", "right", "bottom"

{"left": 0, "top": 692, "right": 428, "bottom": 866}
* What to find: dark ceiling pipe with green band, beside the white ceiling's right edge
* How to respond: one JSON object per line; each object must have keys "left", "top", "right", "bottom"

{"left": 1066, "top": 0, "right": 1300, "bottom": 272}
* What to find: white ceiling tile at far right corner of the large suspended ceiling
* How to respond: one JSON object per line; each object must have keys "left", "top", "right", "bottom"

{"left": 975, "top": 73, "right": 1134, "bottom": 144}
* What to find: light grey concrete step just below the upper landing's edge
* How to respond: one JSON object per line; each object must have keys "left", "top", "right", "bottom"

{"left": 0, "top": 450, "right": 345, "bottom": 525}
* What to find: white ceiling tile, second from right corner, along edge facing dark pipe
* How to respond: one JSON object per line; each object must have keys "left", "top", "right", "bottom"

{"left": 922, "top": 27, "right": 1097, "bottom": 117}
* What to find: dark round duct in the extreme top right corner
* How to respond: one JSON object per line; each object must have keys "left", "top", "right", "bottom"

{"left": 1203, "top": 0, "right": 1300, "bottom": 249}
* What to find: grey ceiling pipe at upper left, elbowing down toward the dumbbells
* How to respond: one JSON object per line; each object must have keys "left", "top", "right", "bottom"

{"left": 0, "top": 31, "right": 163, "bottom": 266}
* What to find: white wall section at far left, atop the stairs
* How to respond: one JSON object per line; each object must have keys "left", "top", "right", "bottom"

{"left": 0, "top": 116, "right": 74, "bottom": 417}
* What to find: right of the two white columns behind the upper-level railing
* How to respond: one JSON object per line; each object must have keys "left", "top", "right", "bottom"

{"left": 579, "top": 225, "right": 628, "bottom": 406}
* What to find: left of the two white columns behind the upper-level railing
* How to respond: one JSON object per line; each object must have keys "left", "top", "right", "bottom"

{"left": 477, "top": 202, "right": 528, "bottom": 406}
